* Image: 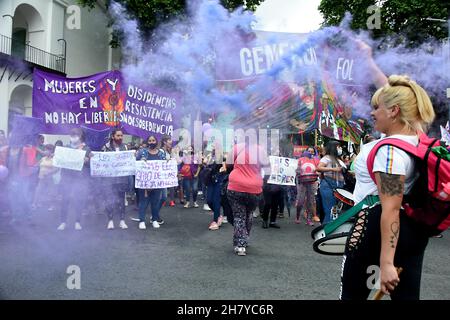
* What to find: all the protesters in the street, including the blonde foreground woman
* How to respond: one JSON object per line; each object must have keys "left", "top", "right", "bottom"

{"left": 0, "top": 76, "right": 442, "bottom": 299}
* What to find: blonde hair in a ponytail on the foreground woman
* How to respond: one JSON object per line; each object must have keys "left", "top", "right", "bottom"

{"left": 372, "top": 75, "right": 435, "bottom": 131}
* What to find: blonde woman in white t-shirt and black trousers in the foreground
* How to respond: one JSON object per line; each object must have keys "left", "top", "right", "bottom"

{"left": 341, "top": 75, "right": 434, "bottom": 300}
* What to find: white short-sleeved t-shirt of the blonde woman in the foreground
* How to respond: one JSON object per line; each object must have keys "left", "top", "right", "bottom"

{"left": 353, "top": 135, "right": 419, "bottom": 203}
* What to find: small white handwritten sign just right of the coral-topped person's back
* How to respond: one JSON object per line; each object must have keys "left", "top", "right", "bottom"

{"left": 267, "top": 156, "right": 298, "bottom": 186}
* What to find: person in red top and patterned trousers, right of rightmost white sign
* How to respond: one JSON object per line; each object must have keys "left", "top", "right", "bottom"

{"left": 295, "top": 147, "right": 320, "bottom": 226}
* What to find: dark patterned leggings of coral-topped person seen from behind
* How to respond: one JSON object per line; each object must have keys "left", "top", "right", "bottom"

{"left": 227, "top": 190, "right": 259, "bottom": 247}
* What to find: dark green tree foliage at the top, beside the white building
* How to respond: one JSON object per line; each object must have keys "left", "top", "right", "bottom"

{"left": 78, "top": 0, "right": 264, "bottom": 47}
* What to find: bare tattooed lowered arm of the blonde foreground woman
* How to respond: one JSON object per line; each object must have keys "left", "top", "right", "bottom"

{"left": 375, "top": 172, "right": 405, "bottom": 294}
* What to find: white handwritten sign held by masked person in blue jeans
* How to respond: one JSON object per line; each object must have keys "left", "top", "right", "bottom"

{"left": 135, "top": 160, "right": 178, "bottom": 189}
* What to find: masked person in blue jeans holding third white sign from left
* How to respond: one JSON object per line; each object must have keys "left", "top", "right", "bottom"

{"left": 136, "top": 135, "right": 165, "bottom": 230}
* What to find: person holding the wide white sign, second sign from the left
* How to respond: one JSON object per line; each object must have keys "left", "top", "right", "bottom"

{"left": 102, "top": 128, "right": 129, "bottom": 230}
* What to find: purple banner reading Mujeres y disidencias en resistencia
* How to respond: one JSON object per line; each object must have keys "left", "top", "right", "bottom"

{"left": 33, "top": 69, "right": 183, "bottom": 139}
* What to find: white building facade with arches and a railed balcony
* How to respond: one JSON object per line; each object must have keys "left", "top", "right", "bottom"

{"left": 0, "top": 0, "right": 120, "bottom": 132}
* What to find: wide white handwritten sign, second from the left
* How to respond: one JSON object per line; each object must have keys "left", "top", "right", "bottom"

{"left": 91, "top": 151, "right": 136, "bottom": 177}
